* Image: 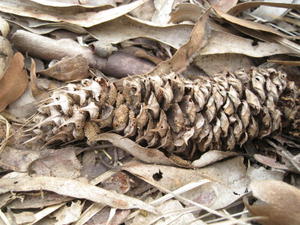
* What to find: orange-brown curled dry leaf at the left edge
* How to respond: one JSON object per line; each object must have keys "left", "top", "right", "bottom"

{"left": 0, "top": 52, "right": 28, "bottom": 112}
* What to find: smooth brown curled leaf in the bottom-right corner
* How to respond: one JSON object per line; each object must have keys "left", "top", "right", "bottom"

{"left": 246, "top": 180, "right": 300, "bottom": 225}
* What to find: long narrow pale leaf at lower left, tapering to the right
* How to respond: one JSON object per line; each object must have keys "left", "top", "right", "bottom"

{"left": 0, "top": 176, "right": 156, "bottom": 213}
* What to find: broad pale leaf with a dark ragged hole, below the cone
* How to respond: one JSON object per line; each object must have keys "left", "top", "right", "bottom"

{"left": 122, "top": 157, "right": 249, "bottom": 209}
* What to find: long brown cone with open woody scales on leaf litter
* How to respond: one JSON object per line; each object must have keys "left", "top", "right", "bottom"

{"left": 31, "top": 68, "right": 299, "bottom": 158}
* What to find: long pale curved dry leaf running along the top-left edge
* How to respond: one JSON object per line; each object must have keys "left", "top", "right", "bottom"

{"left": 0, "top": 0, "right": 148, "bottom": 27}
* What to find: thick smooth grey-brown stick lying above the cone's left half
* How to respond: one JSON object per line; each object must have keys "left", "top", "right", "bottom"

{"left": 12, "top": 30, "right": 154, "bottom": 77}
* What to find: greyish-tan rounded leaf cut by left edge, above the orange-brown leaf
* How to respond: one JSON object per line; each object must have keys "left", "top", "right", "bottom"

{"left": 0, "top": 36, "right": 13, "bottom": 80}
